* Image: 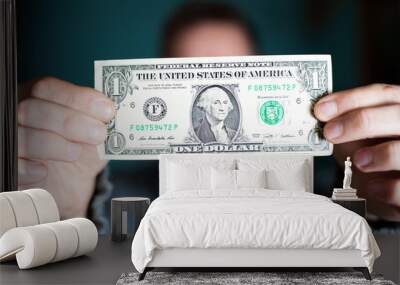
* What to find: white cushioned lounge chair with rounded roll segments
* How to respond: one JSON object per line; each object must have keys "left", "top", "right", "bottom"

{"left": 0, "top": 189, "right": 98, "bottom": 269}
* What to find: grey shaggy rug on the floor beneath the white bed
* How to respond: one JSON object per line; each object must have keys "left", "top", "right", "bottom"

{"left": 117, "top": 270, "right": 395, "bottom": 285}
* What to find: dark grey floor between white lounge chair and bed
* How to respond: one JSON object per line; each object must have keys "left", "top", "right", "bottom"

{"left": 0, "top": 236, "right": 134, "bottom": 285}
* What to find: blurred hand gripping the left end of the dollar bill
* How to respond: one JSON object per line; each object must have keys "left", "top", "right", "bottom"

{"left": 18, "top": 78, "right": 114, "bottom": 218}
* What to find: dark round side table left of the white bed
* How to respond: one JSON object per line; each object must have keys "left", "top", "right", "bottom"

{"left": 111, "top": 197, "right": 150, "bottom": 241}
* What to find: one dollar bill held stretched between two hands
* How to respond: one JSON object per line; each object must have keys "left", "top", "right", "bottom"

{"left": 95, "top": 55, "right": 332, "bottom": 159}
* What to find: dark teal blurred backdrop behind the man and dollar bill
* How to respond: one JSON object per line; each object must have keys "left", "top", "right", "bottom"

{"left": 18, "top": 0, "right": 362, "bottom": 229}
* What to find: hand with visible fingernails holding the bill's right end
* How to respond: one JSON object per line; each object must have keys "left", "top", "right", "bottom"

{"left": 314, "top": 84, "right": 400, "bottom": 221}
